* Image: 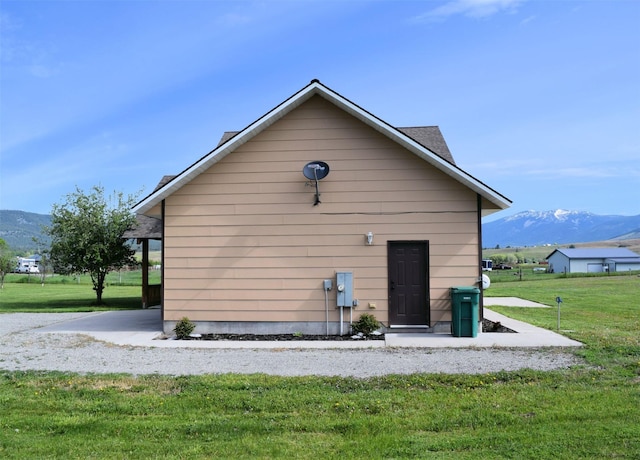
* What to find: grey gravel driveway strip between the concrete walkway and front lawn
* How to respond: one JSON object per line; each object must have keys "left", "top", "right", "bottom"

{"left": 0, "top": 313, "right": 581, "bottom": 377}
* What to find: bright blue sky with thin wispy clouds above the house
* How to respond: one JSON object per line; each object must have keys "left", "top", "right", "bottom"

{"left": 0, "top": 0, "right": 640, "bottom": 223}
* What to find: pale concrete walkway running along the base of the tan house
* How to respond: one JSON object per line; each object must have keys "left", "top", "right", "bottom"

{"left": 34, "top": 297, "right": 582, "bottom": 349}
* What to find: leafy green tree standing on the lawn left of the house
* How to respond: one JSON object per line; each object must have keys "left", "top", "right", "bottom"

{"left": 46, "top": 186, "right": 135, "bottom": 304}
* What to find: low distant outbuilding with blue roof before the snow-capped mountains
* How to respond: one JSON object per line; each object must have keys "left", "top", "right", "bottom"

{"left": 547, "top": 248, "right": 640, "bottom": 273}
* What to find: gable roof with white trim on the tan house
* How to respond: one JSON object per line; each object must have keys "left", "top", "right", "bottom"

{"left": 133, "top": 80, "right": 511, "bottom": 213}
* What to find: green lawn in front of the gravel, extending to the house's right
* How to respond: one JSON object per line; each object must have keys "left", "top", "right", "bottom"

{"left": 0, "top": 276, "right": 640, "bottom": 459}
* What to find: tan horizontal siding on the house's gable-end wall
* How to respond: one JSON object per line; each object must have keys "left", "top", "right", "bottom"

{"left": 164, "top": 96, "right": 478, "bottom": 323}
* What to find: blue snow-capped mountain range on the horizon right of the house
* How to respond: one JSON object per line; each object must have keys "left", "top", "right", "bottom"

{"left": 482, "top": 209, "right": 640, "bottom": 248}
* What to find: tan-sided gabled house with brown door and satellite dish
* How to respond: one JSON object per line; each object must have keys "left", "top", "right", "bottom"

{"left": 134, "top": 80, "right": 511, "bottom": 335}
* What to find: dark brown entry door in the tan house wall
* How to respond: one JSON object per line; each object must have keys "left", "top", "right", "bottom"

{"left": 388, "top": 241, "right": 429, "bottom": 326}
